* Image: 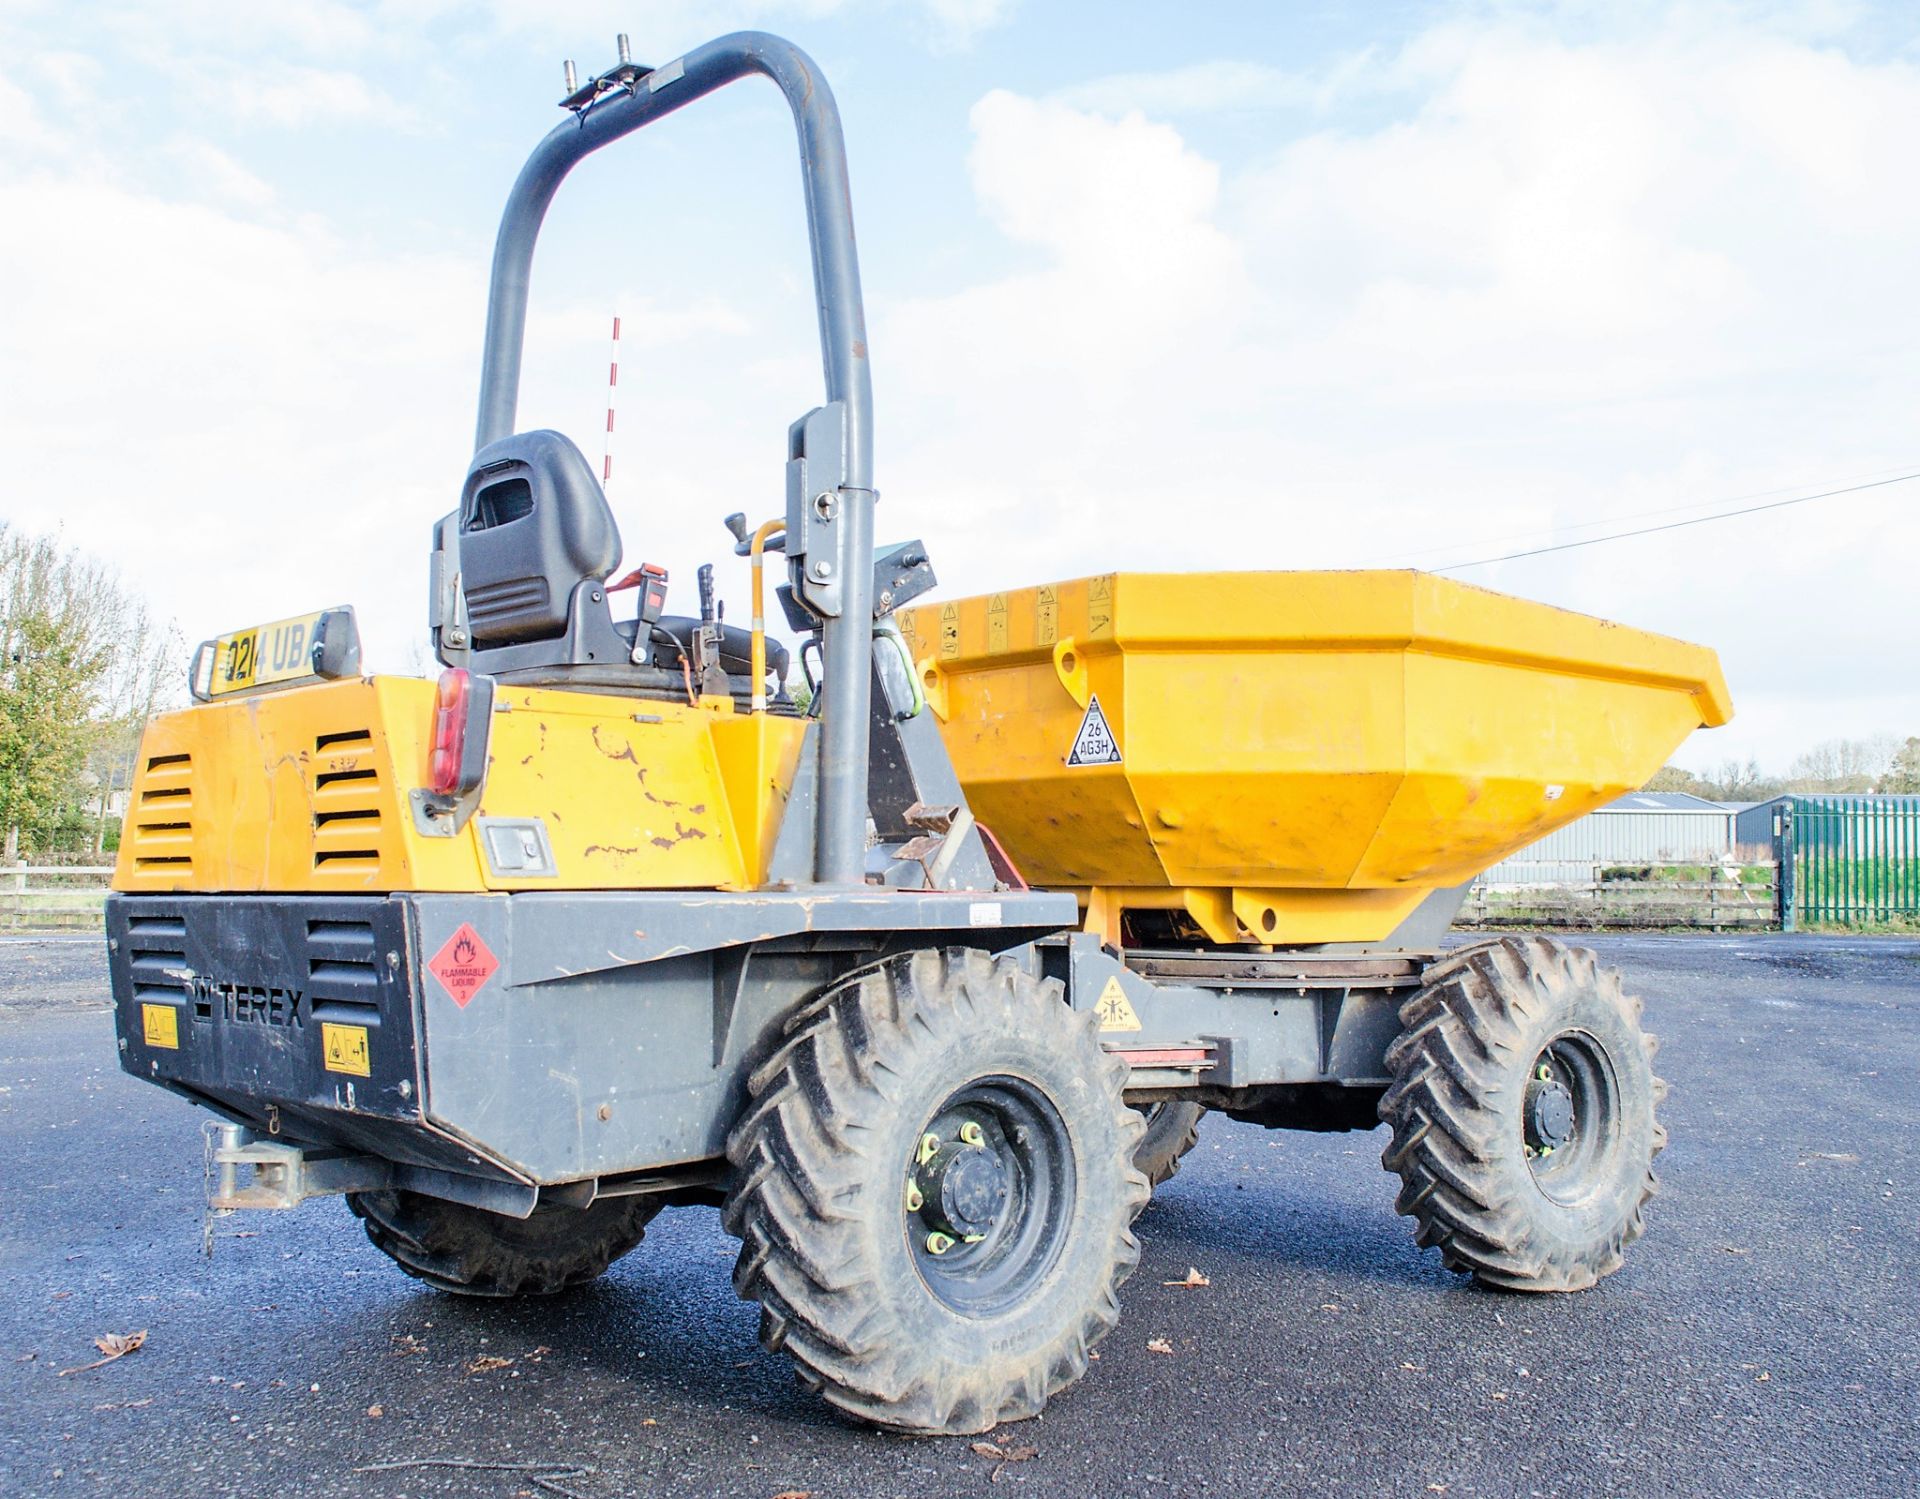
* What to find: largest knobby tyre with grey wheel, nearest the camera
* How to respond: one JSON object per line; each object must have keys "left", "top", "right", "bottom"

{"left": 724, "top": 950, "right": 1148, "bottom": 1434}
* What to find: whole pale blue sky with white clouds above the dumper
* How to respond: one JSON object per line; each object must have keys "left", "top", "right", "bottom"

{"left": 0, "top": 0, "right": 1920, "bottom": 766}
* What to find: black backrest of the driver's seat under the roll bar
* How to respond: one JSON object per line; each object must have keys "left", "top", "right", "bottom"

{"left": 459, "top": 432, "right": 620, "bottom": 649}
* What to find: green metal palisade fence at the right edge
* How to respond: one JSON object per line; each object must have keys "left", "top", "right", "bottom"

{"left": 1782, "top": 797, "right": 1920, "bottom": 927}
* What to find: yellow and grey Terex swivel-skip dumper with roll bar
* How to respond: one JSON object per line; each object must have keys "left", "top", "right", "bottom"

{"left": 108, "top": 33, "right": 1730, "bottom": 1432}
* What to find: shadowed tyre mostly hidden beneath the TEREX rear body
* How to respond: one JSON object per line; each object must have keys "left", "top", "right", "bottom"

{"left": 348, "top": 1192, "right": 660, "bottom": 1296}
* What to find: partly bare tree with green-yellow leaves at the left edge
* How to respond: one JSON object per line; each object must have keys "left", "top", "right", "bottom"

{"left": 0, "top": 522, "right": 177, "bottom": 858}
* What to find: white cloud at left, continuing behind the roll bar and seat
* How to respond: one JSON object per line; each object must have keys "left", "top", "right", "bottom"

{"left": 0, "top": 119, "right": 775, "bottom": 670}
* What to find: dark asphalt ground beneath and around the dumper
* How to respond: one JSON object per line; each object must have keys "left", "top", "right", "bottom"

{"left": 0, "top": 937, "right": 1920, "bottom": 1499}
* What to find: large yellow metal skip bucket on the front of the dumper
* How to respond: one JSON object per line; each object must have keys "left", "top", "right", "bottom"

{"left": 900, "top": 572, "right": 1732, "bottom": 944}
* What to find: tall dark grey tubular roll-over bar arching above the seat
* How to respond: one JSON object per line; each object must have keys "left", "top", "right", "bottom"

{"left": 474, "top": 31, "right": 874, "bottom": 885}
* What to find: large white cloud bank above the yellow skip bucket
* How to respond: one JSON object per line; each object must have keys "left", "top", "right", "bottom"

{"left": 876, "top": 15, "right": 1920, "bottom": 760}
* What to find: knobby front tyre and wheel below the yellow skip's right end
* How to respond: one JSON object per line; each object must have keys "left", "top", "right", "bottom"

{"left": 1380, "top": 937, "right": 1667, "bottom": 1292}
